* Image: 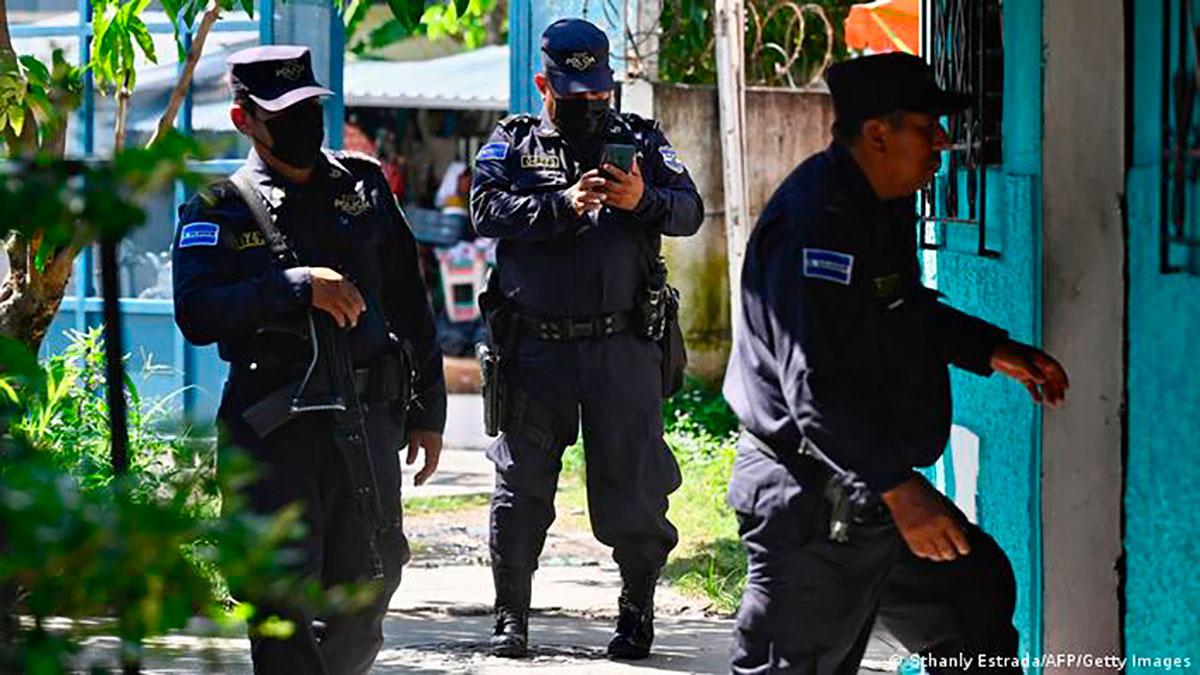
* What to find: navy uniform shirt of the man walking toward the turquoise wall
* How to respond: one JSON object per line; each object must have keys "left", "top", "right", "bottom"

{"left": 725, "top": 142, "right": 1007, "bottom": 491}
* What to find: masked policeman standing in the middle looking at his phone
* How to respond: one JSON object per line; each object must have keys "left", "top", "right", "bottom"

{"left": 470, "top": 19, "right": 703, "bottom": 658}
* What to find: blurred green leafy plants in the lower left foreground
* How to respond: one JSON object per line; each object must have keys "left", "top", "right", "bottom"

{"left": 0, "top": 329, "right": 377, "bottom": 673}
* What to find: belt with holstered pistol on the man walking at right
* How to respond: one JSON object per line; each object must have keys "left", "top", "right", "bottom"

{"left": 740, "top": 429, "right": 892, "bottom": 544}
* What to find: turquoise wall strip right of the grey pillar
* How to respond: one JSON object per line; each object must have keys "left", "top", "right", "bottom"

{"left": 1124, "top": 0, "right": 1200, "bottom": 673}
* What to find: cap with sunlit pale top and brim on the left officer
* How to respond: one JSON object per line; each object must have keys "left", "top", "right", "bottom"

{"left": 229, "top": 44, "right": 334, "bottom": 113}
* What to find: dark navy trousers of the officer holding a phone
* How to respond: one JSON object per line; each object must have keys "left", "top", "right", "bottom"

{"left": 487, "top": 333, "right": 680, "bottom": 573}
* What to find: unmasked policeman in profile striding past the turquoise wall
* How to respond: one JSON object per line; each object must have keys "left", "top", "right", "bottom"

{"left": 725, "top": 54, "right": 1067, "bottom": 674}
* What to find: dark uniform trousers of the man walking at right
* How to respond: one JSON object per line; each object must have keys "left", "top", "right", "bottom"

{"left": 728, "top": 446, "right": 1020, "bottom": 675}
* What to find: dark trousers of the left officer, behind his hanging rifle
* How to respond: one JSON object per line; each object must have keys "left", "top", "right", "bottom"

{"left": 214, "top": 400, "right": 409, "bottom": 675}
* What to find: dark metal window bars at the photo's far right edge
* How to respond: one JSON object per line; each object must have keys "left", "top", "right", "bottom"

{"left": 1159, "top": 0, "right": 1200, "bottom": 274}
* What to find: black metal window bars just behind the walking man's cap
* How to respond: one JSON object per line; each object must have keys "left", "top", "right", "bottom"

{"left": 918, "top": 0, "right": 1004, "bottom": 257}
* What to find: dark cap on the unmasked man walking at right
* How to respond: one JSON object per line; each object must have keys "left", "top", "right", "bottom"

{"left": 826, "top": 52, "right": 971, "bottom": 121}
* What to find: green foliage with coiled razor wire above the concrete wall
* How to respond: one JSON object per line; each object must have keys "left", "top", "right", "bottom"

{"left": 659, "top": 0, "right": 860, "bottom": 86}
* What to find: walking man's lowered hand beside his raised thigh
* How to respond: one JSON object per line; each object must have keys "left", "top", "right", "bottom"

{"left": 882, "top": 476, "right": 971, "bottom": 561}
